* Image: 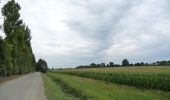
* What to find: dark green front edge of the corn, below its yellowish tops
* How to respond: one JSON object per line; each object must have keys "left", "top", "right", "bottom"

{"left": 55, "top": 66, "right": 170, "bottom": 91}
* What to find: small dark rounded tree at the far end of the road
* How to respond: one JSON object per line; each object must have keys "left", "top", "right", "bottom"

{"left": 36, "top": 59, "right": 48, "bottom": 73}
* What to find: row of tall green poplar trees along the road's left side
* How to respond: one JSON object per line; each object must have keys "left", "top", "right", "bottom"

{"left": 0, "top": 0, "right": 36, "bottom": 77}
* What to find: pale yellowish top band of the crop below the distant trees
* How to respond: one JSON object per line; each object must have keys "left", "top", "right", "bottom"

{"left": 58, "top": 66, "right": 170, "bottom": 74}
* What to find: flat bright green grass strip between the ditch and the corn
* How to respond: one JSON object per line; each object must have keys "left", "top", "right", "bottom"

{"left": 48, "top": 73, "right": 170, "bottom": 100}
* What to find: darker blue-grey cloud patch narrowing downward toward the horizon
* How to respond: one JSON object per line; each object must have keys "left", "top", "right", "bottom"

{"left": 63, "top": 0, "right": 139, "bottom": 60}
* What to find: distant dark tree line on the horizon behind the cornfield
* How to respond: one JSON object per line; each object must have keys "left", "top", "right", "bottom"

{"left": 76, "top": 59, "right": 170, "bottom": 68}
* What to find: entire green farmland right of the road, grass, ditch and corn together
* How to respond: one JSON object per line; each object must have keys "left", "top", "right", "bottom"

{"left": 44, "top": 66, "right": 170, "bottom": 100}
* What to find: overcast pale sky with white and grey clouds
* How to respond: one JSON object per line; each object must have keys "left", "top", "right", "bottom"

{"left": 0, "top": 0, "right": 170, "bottom": 68}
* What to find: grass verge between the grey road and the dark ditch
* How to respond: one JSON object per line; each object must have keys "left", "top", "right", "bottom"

{"left": 42, "top": 74, "right": 76, "bottom": 100}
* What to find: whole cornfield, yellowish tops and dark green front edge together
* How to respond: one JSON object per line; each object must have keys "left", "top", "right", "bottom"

{"left": 56, "top": 67, "right": 170, "bottom": 91}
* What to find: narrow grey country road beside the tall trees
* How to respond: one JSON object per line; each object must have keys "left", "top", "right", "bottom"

{"left": 0, "top": 72, "right": 46, "bottom": 100}
